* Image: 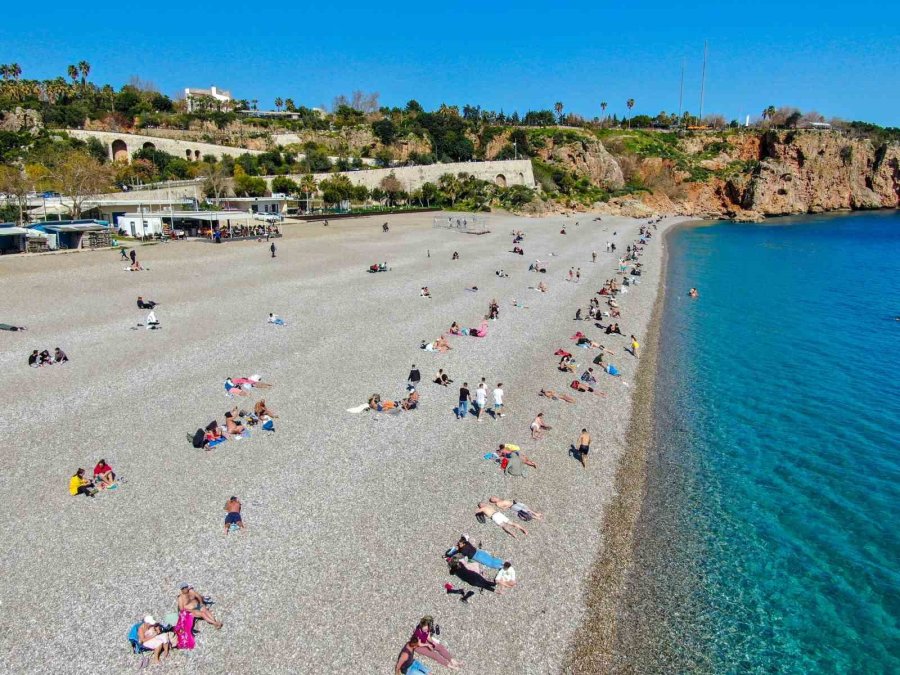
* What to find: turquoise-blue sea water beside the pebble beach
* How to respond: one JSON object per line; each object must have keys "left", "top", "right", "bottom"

{"left": 631, "top": 213, "right": 900, "bottom": 673}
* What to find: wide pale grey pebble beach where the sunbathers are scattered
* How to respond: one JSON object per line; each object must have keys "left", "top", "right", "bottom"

{"left": 0, "top": 213, "right": 684, "bottom": 674}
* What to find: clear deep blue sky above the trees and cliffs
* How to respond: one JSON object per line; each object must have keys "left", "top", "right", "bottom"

{"left": 0, "top": 0, "right": 900, "bottom": 126}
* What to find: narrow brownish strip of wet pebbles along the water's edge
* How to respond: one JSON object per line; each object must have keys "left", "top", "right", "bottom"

{"left": 564, "top": 220, "right": 688, "bottom": 673}
